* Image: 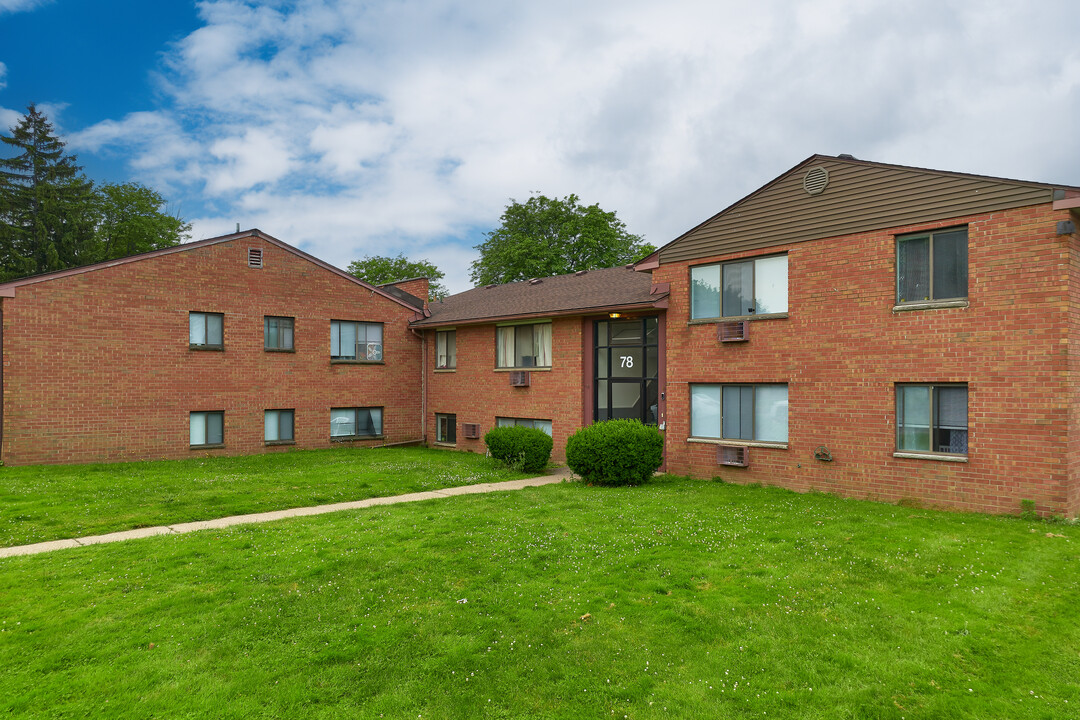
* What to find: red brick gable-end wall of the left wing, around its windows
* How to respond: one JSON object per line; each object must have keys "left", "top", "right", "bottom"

{"left": 0, "top": 239, "right": 422, "bottom": 464}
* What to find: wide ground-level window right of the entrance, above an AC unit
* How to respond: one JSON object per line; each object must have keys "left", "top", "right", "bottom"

{"left": 690, "top": 384, "right": 787, "bottom": 443}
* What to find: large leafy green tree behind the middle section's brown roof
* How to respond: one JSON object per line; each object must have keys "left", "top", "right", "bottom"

{"left": 470, "top": 194, "right": 656, "bottom": 285}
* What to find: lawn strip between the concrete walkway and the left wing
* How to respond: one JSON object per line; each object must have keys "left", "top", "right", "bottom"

{"left": 0, "top": 448, "right": 535, "bottom": 547}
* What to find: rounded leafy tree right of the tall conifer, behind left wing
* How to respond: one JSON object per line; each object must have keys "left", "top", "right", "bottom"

{"left": 96, "top": 182, "right": 191, "bottom": 260}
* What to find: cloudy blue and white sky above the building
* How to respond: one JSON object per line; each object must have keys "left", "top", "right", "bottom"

{"left": 0, "top": 0, "right": 1080, "bottom": 291}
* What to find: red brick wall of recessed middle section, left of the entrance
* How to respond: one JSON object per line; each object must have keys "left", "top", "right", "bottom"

{"left": 424, "top": 317, "right": 592, "bottom": 461}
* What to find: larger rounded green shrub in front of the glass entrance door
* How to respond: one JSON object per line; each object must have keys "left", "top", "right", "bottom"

{"left": 566, "top": 420, "right": 664, "bottom": 485}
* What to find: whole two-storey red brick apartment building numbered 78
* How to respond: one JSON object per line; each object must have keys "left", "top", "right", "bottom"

{"left": 0, "top": 155, "right": 1080, "bottom": 516}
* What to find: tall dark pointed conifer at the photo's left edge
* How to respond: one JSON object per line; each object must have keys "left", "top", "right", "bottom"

{"left": 0, "top": 105, "right": 96, "bottom": 280}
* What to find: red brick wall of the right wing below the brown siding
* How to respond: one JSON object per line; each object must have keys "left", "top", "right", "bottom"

{"left": 653, "top": 205, "right": 1078, "bottom": 514}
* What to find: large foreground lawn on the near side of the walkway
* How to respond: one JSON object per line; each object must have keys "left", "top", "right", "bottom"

{"left": 0, "top": 476, "right": 1080, "bottom": 719}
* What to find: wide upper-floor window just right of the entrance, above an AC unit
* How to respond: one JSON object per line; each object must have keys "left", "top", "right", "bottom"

{"left": 690, "top": 255, "right": 787, "bottom": 320}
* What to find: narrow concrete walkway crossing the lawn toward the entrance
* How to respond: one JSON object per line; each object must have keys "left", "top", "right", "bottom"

{"left": 0, "top": 467, "right": 573, "bottom": 558}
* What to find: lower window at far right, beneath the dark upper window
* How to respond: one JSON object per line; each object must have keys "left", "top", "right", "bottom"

{"left": 896, "top": 384, "right": 968, "bottom": 454}
